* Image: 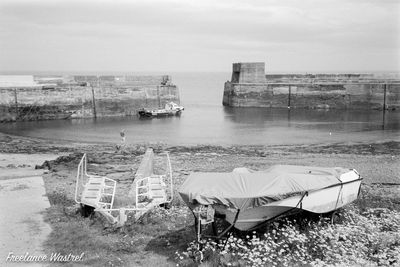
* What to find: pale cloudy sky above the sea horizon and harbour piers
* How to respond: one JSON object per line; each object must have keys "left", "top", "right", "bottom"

{"left": 0, "top": 0, "right": 400, "bottom": 73}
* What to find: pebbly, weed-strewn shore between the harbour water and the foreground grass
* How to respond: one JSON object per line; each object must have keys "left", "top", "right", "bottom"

{"left": 0, "top": 131, "right": 400, "bottom": 206}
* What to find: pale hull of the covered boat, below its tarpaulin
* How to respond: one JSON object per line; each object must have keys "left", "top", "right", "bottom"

{"left": 214, "top": 179, "right": 361, "bottom": 231}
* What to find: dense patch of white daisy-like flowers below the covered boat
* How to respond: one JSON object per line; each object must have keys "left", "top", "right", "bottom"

{"left": 176, "top": 205, "right": 400, "bottom": 266}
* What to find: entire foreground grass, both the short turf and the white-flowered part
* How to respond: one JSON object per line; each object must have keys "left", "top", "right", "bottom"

{"left": 41, "top": 183, "right": 400, "bottom": 266}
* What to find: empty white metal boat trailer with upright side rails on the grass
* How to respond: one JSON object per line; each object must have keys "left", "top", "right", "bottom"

{"left": 75, "top": 149, "right": 173, "bottom": 227}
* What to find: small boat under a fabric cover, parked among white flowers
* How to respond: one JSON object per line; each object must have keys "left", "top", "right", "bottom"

{"left": 179, "top": 165, "right": 362, "bottom": 231}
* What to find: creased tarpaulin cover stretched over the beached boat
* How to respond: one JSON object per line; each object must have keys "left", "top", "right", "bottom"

{"left": 179, "top": 165, "right": 350, "bottom": 210}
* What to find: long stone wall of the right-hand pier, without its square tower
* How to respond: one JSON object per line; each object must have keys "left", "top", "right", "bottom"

{"left": 223, "top": 82, "right": 400, "bottom": 109}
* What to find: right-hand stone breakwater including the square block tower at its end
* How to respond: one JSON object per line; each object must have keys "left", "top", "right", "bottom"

{"left": 223, "top": 62, "right": 400, "bottom": 109}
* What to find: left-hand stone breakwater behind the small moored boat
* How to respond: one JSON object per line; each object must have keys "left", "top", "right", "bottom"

{"left": 0, "top": 75, "right": 180, "bottom": 122}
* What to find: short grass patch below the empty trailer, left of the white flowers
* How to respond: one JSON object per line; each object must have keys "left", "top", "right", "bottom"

{"left": 45, "top": 192, "right": 194, "bottom": 266}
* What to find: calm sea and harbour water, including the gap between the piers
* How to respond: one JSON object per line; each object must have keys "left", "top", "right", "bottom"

{"left": 0, "top": 72, "right": 400, "bottom": 146}
